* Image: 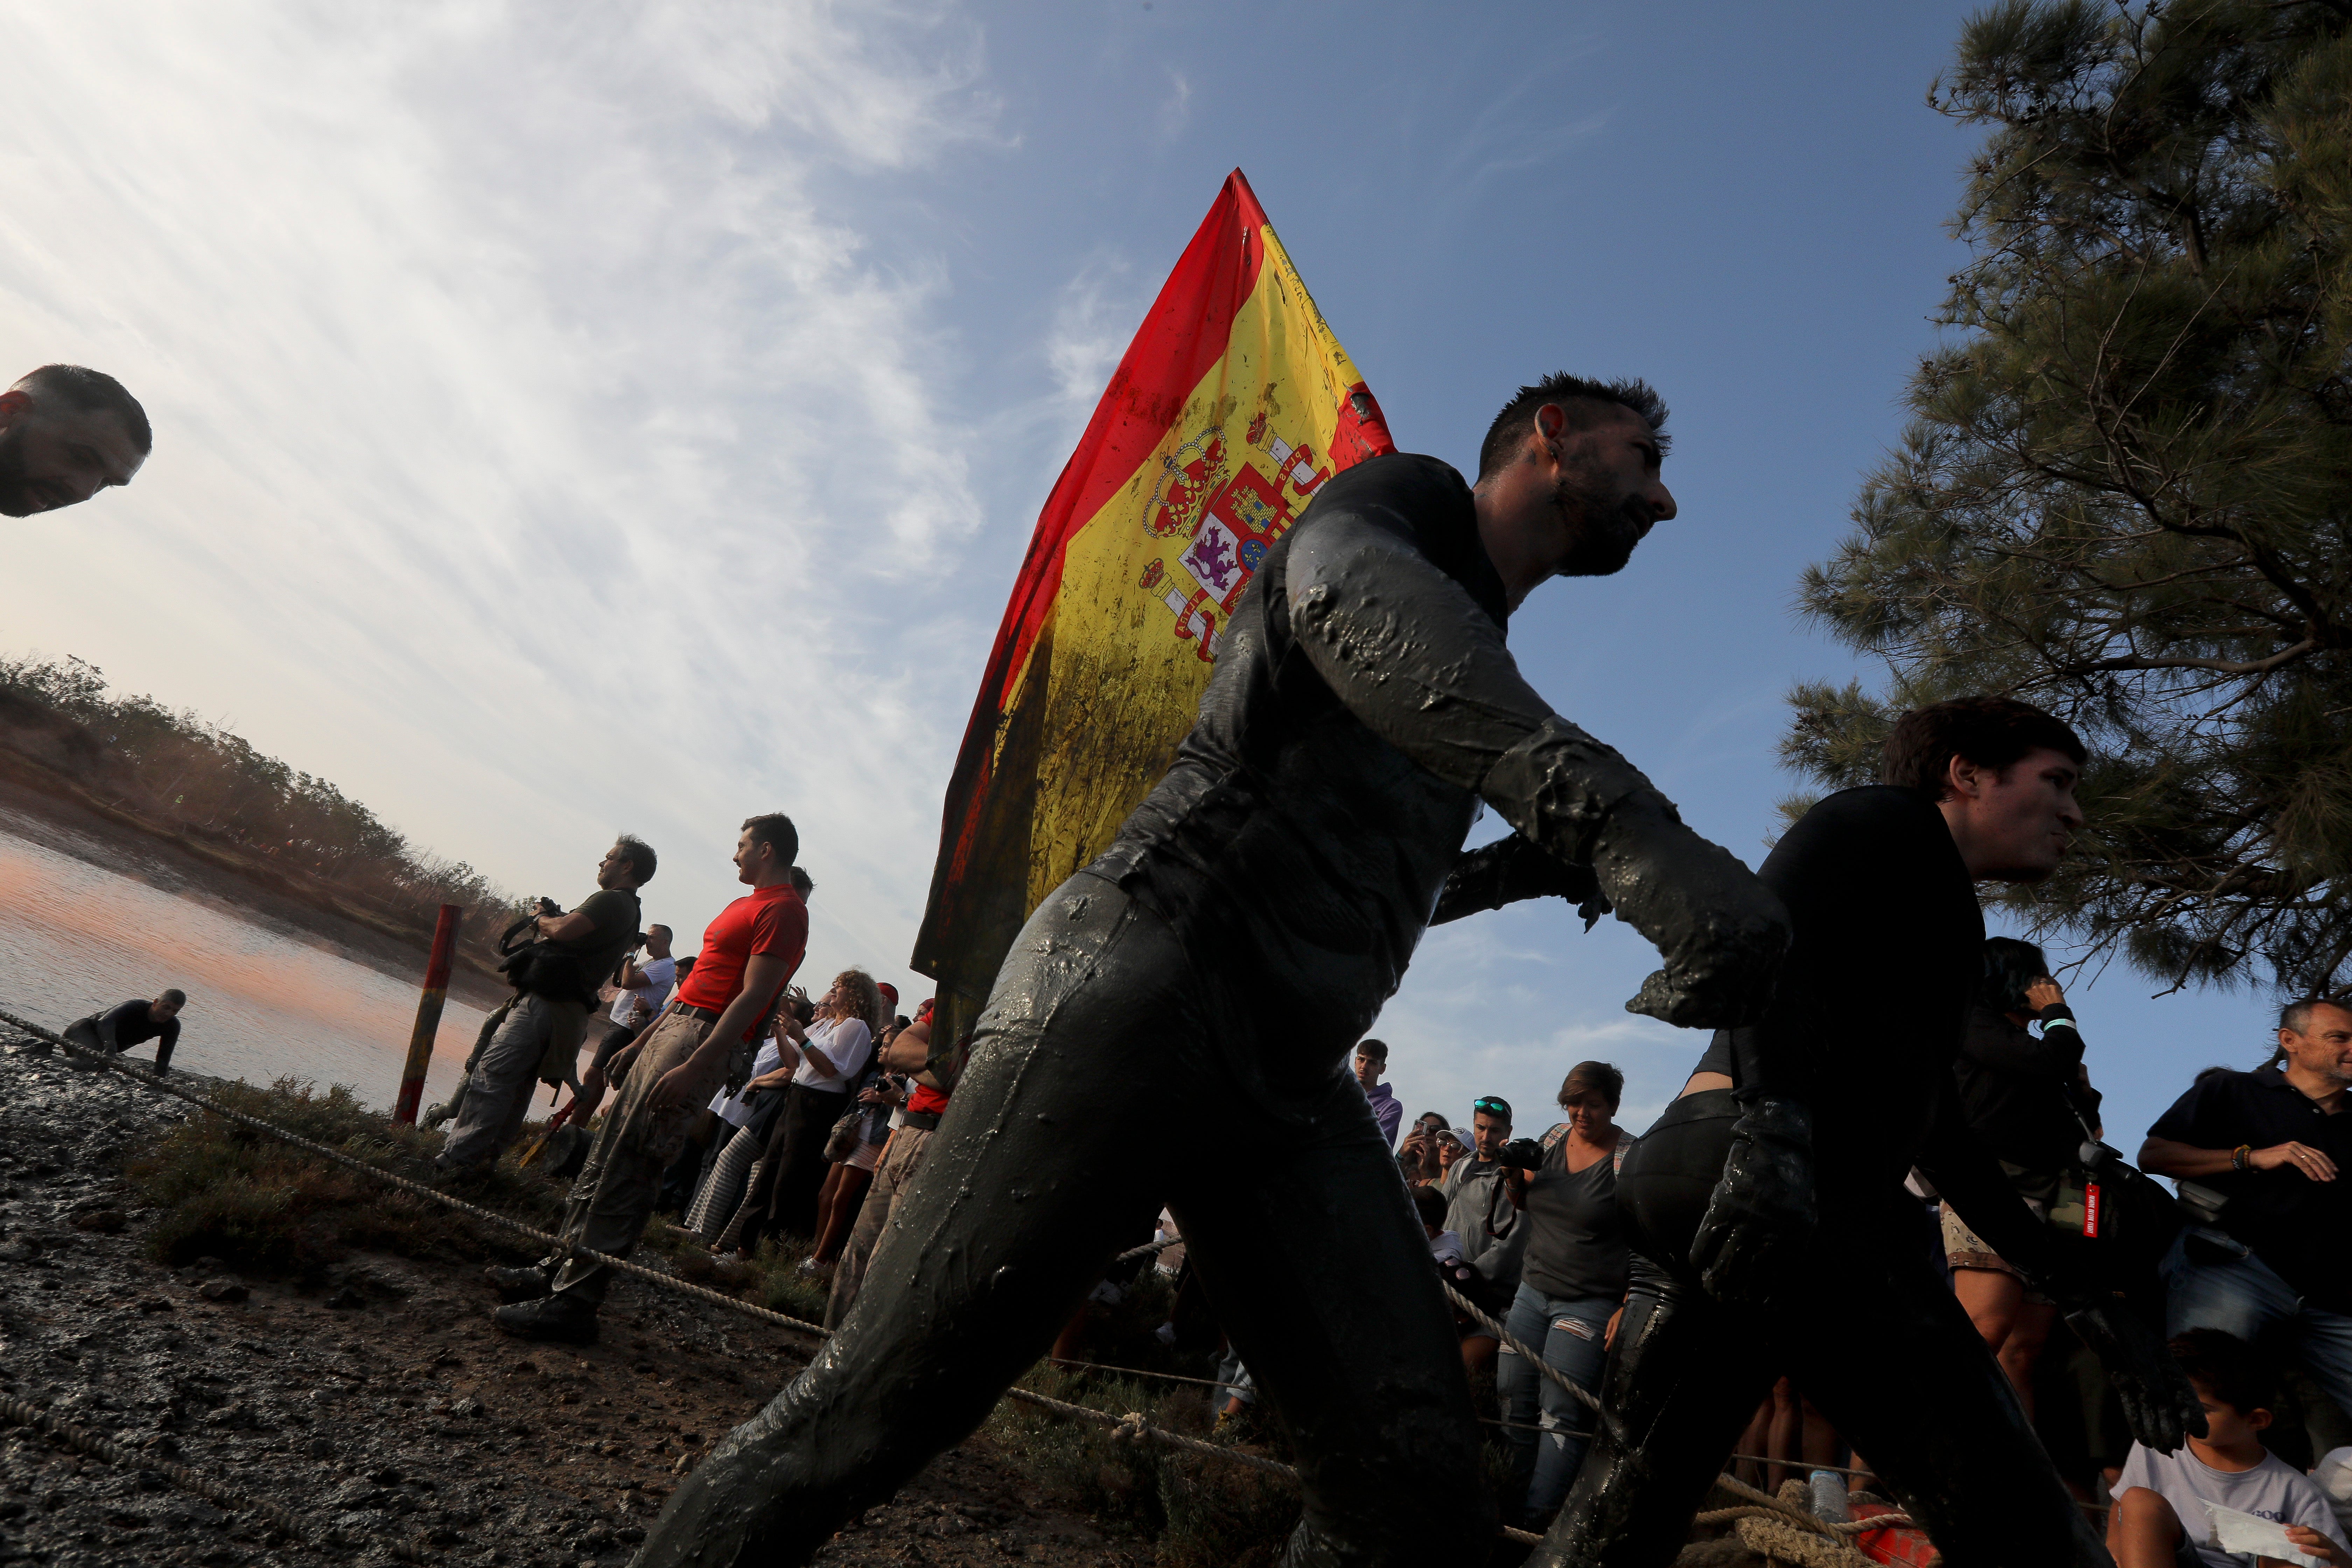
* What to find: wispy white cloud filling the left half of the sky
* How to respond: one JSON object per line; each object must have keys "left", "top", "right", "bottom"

{"left": 0, "top": 2, "right": 995, "bottom": 973}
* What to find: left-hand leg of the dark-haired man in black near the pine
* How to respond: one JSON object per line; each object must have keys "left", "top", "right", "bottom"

{"left": 1526, "top": 1255, "right": 1769, "bottom": 1568}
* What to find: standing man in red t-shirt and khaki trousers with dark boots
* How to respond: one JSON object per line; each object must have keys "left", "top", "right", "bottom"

{"left": 489, "top": 811, "right": 809, "bottom": 1345}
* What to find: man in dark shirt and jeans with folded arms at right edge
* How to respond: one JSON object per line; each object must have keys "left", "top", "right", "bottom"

{"left": 2140, "top": 999, "right": 2352, "bottom": 1438}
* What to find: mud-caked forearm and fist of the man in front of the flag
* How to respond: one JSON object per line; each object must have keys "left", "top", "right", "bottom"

{"left": 1479, "top": 717, "right": 1790, "bottom": 1030}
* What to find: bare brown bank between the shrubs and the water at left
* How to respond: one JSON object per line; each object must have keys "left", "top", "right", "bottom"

{"left": 0, "top": 757, "right": 510, "bottom": 1011}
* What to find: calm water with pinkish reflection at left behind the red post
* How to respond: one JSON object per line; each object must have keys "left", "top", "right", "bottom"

{"left": 0, "top": 809, "right": 482, "bottom": 1107}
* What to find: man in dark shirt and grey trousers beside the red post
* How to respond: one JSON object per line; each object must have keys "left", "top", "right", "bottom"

{"left": 433, "top": 832, "right": 656, "bottom": 1175}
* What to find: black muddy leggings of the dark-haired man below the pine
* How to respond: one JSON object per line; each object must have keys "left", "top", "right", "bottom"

{"left": 1529, "top": 1091, "right": 2112, "bottom": 1568}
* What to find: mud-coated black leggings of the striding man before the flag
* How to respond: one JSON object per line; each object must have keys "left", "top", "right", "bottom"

{"left": 637, "top": 872, "right": 1493, "bottom": 1568}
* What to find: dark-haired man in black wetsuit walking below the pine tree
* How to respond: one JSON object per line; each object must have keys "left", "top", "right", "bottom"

{"left": 1529, "top": 698, "right": 2204, "bottom": 1568}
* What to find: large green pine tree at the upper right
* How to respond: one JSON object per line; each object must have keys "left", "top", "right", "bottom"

{"left": 1780, "top": 0, "right": 2352, "bottom": 992}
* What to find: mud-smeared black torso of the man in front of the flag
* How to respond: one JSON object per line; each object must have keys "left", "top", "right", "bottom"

{"left": 1091, "top": 454, "right": 1508, "bottom": 1072}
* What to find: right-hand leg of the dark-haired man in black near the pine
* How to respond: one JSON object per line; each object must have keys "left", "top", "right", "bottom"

{"left": 1790, "top": 1258, "right": 2110, "bottom": 1568}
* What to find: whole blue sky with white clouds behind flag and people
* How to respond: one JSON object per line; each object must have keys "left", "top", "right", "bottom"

{"left": 0, "top": 0, "right": 2265, "bottom": 1147}
